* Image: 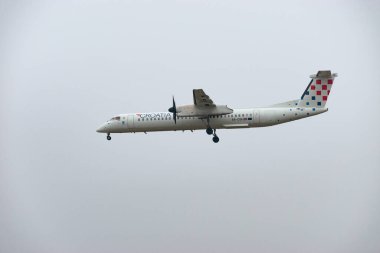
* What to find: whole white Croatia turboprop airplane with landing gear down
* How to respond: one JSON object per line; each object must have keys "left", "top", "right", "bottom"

{"left": 96, "top": 70, "right": 338, "bottom": 143}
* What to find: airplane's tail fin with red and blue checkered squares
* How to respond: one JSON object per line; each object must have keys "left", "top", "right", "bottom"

{"left": 298, "top": 70, "right": 338, "bottom": 108}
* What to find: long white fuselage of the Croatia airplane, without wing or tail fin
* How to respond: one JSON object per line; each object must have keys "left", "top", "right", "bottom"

{"left": 97, "top": 107, "right": 327, "bottom": 133}
